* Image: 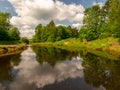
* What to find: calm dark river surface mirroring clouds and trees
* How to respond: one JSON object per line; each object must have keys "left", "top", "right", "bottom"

{"left": 0, "top": 46, "right": 120, "bottom": 90}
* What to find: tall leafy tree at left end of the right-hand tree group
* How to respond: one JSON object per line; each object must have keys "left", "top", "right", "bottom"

{"left": 79, "top": 5, "right": 103, "bottom": 41}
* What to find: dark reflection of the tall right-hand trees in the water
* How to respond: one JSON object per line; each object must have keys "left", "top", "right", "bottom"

{"left": 81, "top": 53, "right": 120, "bottom": 90}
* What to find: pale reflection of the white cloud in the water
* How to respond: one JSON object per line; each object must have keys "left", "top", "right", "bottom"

{"left": 0, "top": 48, "right": 84, "bottom": 90}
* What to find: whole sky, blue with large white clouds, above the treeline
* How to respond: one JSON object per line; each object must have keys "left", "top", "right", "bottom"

{"left": 0, "top": 0, "right": 106, "bottom": 38}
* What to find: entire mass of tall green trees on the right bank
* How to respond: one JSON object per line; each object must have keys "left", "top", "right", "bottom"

{"left": 79, "top": 0, "right": 120, "bottom": 41}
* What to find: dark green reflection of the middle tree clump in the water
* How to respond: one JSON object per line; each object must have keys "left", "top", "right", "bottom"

{"left": 31, "top": 46, "right": 78, "bottom": 66}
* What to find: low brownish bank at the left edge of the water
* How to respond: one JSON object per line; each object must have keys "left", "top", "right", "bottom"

{"left": 0, "top": 44, "right": 27, "bottom": 56}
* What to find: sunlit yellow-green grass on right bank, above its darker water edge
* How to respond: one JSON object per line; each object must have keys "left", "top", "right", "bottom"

{"left": 51, "top": 37, "right": 120, "bottom": 52}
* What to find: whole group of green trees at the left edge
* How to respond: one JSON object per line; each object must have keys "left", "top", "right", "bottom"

{"left": 0, "top": 12, "right": 20, "bottom": 42}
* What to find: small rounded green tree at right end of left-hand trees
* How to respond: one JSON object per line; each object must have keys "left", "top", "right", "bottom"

{"left": 9, "top": 27, "right": 20, "bottom": 40}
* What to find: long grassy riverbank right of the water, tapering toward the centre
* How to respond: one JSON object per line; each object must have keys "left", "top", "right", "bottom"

{"left": 32, "top": 37, "right": 120, "bottom": 60}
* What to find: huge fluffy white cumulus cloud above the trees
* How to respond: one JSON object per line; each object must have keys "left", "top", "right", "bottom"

{"left": 8, "top": 0, "right": 84, "bottom": 37}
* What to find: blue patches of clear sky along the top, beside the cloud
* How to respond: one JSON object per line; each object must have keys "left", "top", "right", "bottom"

{"left": 0, "top": 0, "right": 106, "bottom": 15}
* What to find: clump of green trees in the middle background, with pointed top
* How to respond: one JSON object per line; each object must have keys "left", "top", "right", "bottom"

{"left": 33, "top": 20, "right": 78, "bottom": 42}
